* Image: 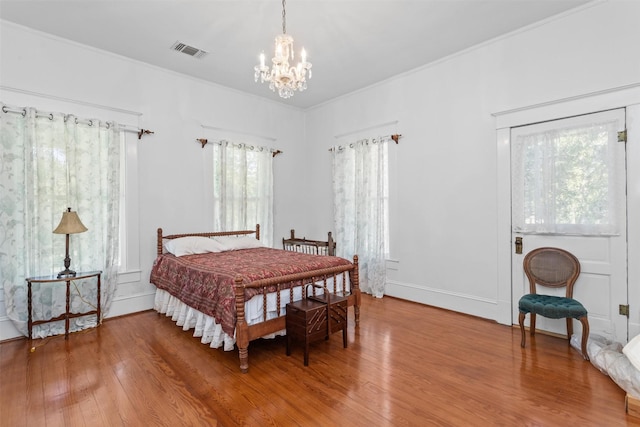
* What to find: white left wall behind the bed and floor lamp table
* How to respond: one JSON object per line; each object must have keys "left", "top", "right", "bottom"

{"left": 0, "top": 21, "right": 304, "bottom": 340}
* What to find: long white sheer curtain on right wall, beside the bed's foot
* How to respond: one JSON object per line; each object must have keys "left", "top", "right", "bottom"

{"left": 331, "top": 137, "right": 389, "bottom": 298}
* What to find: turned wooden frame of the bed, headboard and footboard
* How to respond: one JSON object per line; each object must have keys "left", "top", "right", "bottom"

{"left": 152, "top": 225, "right": 361, "bottom": 373}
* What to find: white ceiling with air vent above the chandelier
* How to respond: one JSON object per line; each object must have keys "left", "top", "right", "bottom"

{"left": 0, "top": 0, "right": 591, "bottom": 108}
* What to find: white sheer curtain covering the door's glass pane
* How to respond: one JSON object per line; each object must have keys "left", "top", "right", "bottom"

{"left": 512, "top": 111, "right": 625, "bottom": 235}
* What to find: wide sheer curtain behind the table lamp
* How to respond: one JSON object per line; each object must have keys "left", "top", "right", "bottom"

{"left": 0, "top": 105, "right": 120, "bottom": 338}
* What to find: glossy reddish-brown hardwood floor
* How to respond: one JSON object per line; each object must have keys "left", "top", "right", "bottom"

{"left": 0, "top": 296, "right": 640, "bottom": 427}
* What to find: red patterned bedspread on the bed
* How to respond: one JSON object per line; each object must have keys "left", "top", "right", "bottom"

{"left": 149, "top": 248, "right": 351, "bottom": 336}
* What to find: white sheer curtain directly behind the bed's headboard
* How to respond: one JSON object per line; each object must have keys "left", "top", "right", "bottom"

{"left": 213, "top": 140, "right": 273, "bottom": 246}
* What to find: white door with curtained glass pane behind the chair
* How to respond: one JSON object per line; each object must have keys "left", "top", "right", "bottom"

{"left": 511, "top": 109, "right": 628, "bottom": 343}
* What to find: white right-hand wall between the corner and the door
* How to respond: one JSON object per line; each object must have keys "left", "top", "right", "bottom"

{"left": 306, "top": 1, "right": 640, "bottom": 323}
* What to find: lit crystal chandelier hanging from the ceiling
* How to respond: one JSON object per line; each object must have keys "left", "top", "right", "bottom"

{"left": 254, "top": 0, "right": 311, "bottom": 99}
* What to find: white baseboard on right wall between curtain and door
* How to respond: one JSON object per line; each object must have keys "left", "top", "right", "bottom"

{"left": 385, "top": 281, "right": 511, "bottom": 325}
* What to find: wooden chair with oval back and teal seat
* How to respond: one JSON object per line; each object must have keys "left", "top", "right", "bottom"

{"left": 518, "top": 248, "right": 589, "bottom": 360}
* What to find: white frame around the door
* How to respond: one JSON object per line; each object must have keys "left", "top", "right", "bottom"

{"left": 493, "top": 83, "right": 640, "bottom": 339}
